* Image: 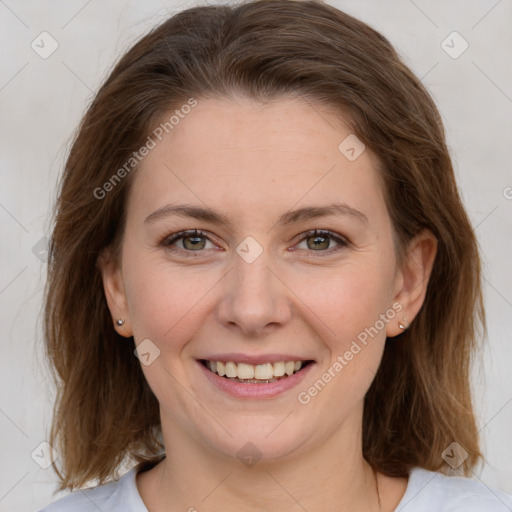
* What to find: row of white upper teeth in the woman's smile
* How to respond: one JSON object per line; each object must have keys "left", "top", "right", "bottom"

{"left": 206, "top": 361, "right": 304, "bottom": 382}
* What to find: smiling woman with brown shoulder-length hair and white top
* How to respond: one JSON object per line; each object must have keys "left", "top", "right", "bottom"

{"left": 39, "top": 0, "right": 512, "bottom": 512}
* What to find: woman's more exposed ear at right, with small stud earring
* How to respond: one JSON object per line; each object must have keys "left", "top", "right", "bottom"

{"left": 386, "top": 229, "right": 437, "bottom": 338}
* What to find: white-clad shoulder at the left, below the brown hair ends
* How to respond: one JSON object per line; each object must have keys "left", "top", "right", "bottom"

{"left": 40, "top": 468, "right": 148, "bottom": 512}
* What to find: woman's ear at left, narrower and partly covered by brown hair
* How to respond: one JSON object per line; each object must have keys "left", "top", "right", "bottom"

{"left": 97, "top": 248, "right": 133, "bottom": 338}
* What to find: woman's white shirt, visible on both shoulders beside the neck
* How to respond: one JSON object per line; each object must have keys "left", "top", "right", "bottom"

{"left": 39, "top": 467, "right": 512, "bottom": 512}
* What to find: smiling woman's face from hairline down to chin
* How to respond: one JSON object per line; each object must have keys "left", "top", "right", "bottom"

{"left": 103, "top": 99, "right": 418, "bottom": 459}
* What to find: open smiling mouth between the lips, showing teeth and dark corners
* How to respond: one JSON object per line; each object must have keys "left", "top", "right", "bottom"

{"left": 199, "top": 359, "right": 314, "bottom": 384}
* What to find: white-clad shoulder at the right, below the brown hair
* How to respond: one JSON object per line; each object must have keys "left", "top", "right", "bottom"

{"left": 395, "top": 468, "right": 512, "bottom": 512}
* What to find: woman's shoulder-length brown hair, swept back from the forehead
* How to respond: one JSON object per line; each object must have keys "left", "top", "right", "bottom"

{"left": 45, "top": 0, "right": 485, "bottom": 490}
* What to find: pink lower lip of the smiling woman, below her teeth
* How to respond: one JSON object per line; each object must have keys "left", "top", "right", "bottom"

{"left": 197, "top": 361, "right": 315, "bottom": 398}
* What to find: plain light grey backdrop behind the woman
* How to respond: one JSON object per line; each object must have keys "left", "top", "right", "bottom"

{"left": 0, "top": 0, "right": 512, "bottom": 512}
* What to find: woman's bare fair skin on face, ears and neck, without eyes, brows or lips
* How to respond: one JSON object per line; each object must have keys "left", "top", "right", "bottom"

{"left": 101, "top": 98, "right": 436, "bottom": 512}
